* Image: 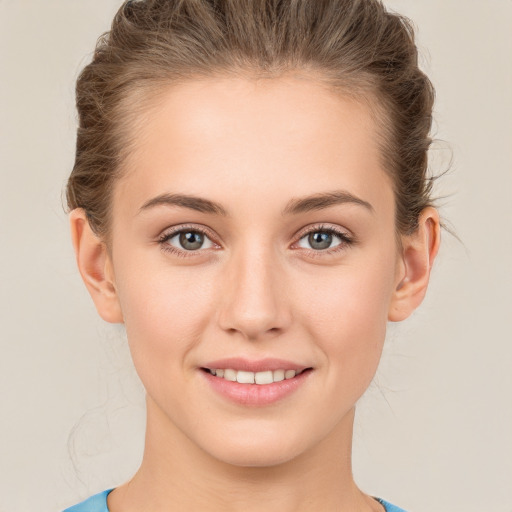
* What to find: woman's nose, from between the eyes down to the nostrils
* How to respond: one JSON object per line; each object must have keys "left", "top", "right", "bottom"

{"left": 217, "top": 239, "right": 291, "bottom": 341}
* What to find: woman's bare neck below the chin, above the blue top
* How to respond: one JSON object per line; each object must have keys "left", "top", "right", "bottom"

{"left": 108, "top": 400, "right": 382, "bottom": 512}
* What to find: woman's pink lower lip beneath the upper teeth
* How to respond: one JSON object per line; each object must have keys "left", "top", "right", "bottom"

{"left": 199, "top": 369, "right": 312, "bottom": 407}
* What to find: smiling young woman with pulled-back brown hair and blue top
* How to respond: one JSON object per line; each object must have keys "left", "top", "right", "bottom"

{"left": 63, "top": 0, "right": 440, "bottom": 512}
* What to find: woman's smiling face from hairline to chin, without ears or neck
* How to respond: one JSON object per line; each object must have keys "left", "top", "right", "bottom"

{"left": 111, "top": 77, "right": 400, "bottom": 466}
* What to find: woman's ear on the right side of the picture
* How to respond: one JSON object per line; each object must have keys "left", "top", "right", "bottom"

{"left": 388, "top": 207, "right": 441, "bottom": 322}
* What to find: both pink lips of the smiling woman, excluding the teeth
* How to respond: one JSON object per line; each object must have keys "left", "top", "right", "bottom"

{"left": 199, "top": 358, "right": 311, "bottom": 407}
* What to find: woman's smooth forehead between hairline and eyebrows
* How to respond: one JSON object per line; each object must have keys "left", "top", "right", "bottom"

{"left": 114, "top": 76, "right": 392, "bottom": 219}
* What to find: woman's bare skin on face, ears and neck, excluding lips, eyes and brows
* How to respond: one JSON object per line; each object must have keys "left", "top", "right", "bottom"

{"left": 70, "top": 76, "right": 439, "bottom": 512}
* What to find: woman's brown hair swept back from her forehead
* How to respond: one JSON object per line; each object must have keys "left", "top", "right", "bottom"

{"left": 67, "top": 0, "right": 434, "bottom": 237}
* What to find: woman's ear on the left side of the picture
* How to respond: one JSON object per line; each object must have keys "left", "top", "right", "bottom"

{"left": 69, "top": 208, "right": 123, "bottom": 323}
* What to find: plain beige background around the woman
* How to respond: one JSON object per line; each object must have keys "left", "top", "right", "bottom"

{"left": 0, "top": 0, "right": 512, "bottom": 512}
